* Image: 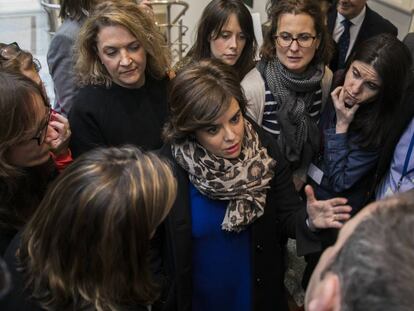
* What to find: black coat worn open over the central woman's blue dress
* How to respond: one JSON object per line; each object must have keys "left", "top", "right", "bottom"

{"left": 155, "top": 121, "right": 321, "bottom": 311}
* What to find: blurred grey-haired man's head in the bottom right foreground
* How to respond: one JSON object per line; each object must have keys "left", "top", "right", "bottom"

{"left": 305, "top": 190, "right": 414, "bottom": 311}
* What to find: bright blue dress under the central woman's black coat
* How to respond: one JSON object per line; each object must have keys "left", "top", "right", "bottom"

{"left": 190, "top": 184, "right": 252, "bottom": 311}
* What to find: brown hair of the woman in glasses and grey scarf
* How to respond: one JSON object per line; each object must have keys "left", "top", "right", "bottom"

{"left": 260, "top": 0, "right": 333, "bottom": 65}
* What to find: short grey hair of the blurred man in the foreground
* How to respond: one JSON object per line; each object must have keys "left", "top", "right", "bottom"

{"left": 325, "top": 190, "right": 414, "bottom": 311}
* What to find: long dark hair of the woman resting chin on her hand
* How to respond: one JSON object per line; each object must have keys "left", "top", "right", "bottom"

{"left": 345, "top": 33, "right": 412, "bottom": 149}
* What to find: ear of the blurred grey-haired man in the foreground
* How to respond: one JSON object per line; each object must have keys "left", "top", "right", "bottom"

{"left": 306, "top": 273, "right": 341, "bottom": 311}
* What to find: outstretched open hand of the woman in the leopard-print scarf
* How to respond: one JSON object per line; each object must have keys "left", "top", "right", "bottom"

{"left": 305, "top": 185, "right": 352, "bottom": 230}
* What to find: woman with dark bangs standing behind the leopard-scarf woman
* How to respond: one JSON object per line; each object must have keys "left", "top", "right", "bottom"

{"left": 175, "top": 0, "right": 257, "bottom": 80}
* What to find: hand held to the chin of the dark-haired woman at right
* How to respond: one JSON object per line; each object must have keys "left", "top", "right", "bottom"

{"left": 331, "top": 86, "right": 359, "bottom": 134}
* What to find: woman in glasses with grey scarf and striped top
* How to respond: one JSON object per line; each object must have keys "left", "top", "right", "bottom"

{"left": 242, "top": 0, "right": 332, "bottom": 190}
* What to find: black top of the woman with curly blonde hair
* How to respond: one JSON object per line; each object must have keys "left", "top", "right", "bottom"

{"left": 69, "top": 75, "right": 168, "bottom": 157}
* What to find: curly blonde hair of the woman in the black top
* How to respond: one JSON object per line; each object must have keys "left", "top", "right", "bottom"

{"left": 75, "top": 0, "right": 170, "bottom": 87}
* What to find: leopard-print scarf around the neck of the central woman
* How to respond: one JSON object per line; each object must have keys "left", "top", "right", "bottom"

{"left": 171, "top": 119, "right": 276, "bottom": 232}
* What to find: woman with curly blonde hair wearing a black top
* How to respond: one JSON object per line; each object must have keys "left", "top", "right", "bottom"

{"left": 69, "top": 1, "right": 169, "bottom": 157}
